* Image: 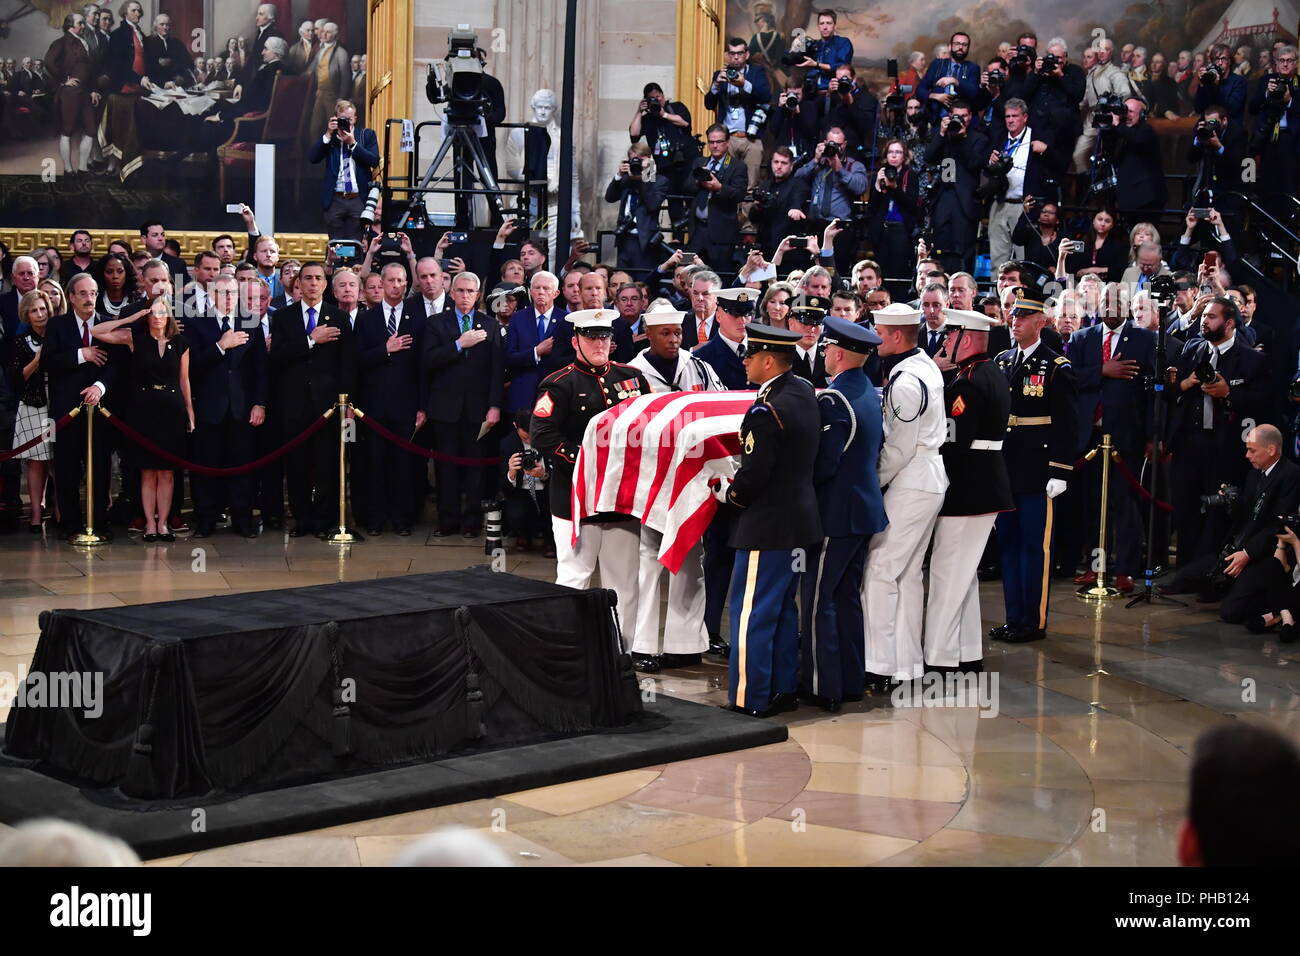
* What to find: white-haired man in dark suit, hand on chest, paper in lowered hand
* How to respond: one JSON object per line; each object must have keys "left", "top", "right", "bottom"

{"left": 420, "top": 272, "right": 503, "bottom": 537}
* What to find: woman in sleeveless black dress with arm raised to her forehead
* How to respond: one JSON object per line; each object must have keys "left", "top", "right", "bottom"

{"left": 91, "top": 297, "right": 194, "bottom": 542}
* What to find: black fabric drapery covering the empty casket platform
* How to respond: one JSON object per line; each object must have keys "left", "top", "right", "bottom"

{"left": 3, "top": 568, "right": 641, "bottom": 801}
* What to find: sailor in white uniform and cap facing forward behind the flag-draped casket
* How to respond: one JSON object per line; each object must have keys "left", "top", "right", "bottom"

{"left": 628, "top": 300, "right": 723, "bottom": 674}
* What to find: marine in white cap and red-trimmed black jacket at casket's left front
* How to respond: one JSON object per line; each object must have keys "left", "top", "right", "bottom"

{"left": 529, "top": 308, "right": 650, "bottom": 644}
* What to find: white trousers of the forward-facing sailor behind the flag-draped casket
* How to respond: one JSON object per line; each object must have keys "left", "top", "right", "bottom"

{"left": 632, "top": 524, "right": 709, "bottom": 656}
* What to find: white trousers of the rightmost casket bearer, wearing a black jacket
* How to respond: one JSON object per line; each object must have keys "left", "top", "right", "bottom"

{"left": 926, "top": 515, "right": 997, "bottom": 667}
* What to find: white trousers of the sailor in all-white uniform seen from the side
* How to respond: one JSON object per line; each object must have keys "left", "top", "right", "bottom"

{"left": 862, "top": 486, "right": 944, "bottom": 680}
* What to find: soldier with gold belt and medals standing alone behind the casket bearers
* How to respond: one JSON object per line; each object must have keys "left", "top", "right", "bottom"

{"left": 989, "top": 289, "right": 1078, "bottom": 644}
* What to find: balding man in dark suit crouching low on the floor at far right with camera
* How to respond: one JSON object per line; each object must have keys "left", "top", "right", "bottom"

{"left": 1165, "top": 425, "right": 1300, "bottom": 624}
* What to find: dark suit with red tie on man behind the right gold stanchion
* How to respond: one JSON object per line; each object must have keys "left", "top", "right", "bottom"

{"left": 1063, "top": 308, "right": 1156, "bottom": 593}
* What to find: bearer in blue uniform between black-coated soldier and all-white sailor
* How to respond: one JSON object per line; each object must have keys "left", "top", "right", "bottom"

{"left": 800, "top": 316, "right": 888, "bottom": 713}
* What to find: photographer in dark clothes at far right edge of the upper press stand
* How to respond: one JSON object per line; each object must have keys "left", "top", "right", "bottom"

{"left": 1251, "top": 46, "right": 1300, "bottom": 214}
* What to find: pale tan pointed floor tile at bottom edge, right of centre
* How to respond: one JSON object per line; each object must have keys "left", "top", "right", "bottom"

{"left": 658, "top": 818, "right": 914, "bottom": 866}
